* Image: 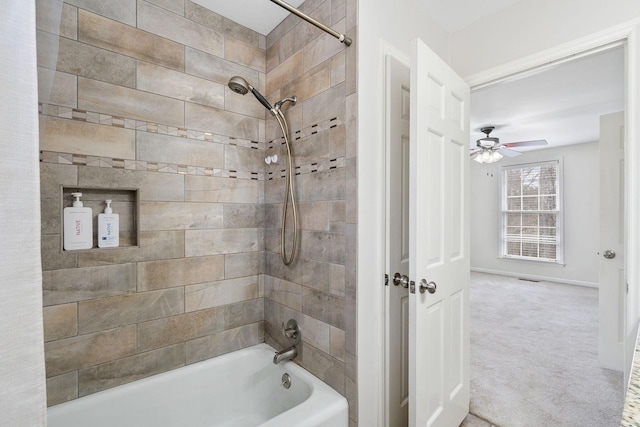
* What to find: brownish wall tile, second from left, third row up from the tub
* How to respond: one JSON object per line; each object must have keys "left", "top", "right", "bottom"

{"left": 78, "top": 288, "right": 184, "bottom": 334}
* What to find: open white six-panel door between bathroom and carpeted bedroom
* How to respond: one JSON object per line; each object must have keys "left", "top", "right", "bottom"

{"left": 409, "top": 39, "right": 470, "bottom": 427}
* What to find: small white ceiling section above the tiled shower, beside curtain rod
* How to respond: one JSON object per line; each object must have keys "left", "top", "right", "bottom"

{"left": 193, "top": 0, "right": 304, "bottom": 36}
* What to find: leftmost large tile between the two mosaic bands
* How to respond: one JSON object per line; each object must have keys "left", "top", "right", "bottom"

{"left": 39, "top": 115, "right": 135, "bottom": 158}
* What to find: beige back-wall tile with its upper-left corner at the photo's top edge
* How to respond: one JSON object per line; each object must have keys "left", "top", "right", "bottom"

{"left": 137, "top": 0, "right": 224, "bottom": 57}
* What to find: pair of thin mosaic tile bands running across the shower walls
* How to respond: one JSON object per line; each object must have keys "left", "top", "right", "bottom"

{"left": 38, "top": 104, "right": 345, "bottom": 181}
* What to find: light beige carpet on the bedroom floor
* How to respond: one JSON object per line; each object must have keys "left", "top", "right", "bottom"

{"left": 470, "top": 273, "right": 624, "bottom": 427}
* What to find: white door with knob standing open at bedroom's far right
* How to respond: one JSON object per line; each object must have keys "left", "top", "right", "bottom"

{"left": 598, "top": 112, "right": 626, "bottom": 371}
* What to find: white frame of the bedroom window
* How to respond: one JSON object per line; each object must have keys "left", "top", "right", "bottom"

{"left": 498, "top": 157, "right": 564, "bottom": 265}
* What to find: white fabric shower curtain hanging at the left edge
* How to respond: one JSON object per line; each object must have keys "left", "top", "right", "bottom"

{"left": 0, "top": 2, "right": 46, "bottom": 427}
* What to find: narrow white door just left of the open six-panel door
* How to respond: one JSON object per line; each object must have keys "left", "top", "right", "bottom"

{"left": 385, "top": 56, "right": 410, "bottom": 427}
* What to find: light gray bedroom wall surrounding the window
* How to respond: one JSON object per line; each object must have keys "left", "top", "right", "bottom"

{"left": 471, "top": 142, "right": 600, "bottom": 286}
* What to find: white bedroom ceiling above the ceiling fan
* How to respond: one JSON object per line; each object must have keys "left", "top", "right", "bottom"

{"left": 471, "top": 47, "right": 624, "bottom": 151}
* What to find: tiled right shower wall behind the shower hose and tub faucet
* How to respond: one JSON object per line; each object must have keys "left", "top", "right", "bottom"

{"left": 264, "top": 0, "right": 357, "bottom": 425}
